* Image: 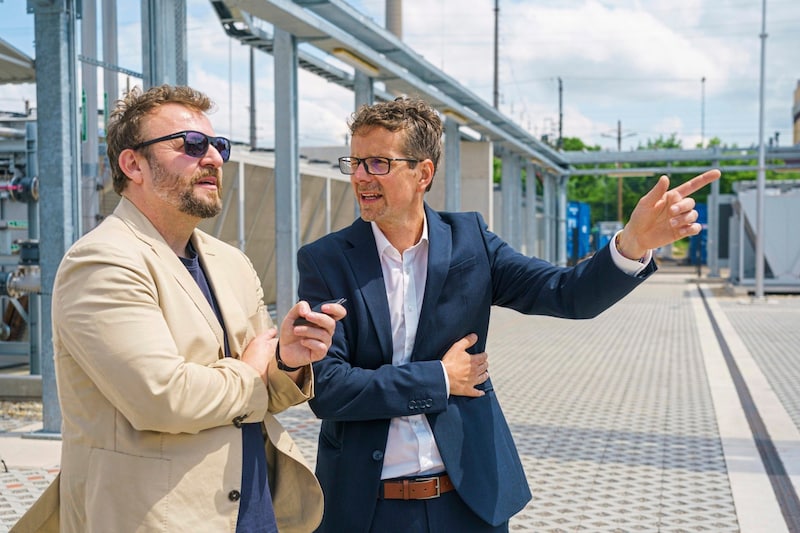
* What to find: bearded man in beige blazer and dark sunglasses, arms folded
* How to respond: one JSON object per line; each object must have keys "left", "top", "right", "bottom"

{"left": 12, "top": 86, "right": 345, "bottom": 533}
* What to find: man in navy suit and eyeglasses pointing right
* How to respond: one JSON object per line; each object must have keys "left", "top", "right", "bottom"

{"left": 298, "top": 98, "right": 720, "bottom": 533}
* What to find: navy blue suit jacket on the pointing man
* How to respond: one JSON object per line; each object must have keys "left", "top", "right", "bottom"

{"left": 298, "top": 205, "right": 655, "bottom": 533}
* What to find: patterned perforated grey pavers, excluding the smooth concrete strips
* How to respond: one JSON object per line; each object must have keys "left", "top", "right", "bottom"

{"left": 0, "top": 270, "right": 800, "bottom": 533}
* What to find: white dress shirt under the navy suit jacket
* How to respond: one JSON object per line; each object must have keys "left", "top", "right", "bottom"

{"left": 371, "top": 217, "right": 653, "bottom": 479}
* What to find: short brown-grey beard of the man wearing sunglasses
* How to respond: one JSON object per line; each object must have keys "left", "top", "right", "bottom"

{"left": 150, "top": 154, "right": 222, "bottom": 218}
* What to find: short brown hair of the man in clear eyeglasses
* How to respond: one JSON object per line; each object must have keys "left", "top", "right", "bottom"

{"left": 349, "top": 96, "right": 442, "bottom": 189}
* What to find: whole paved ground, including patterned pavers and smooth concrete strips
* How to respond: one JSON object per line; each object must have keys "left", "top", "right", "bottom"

{"left": 0, "top": 268, "right": 800, "bottom": 533}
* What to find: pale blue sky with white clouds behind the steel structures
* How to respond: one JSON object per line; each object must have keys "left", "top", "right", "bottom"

{"left": 0, "top": 0, "right": 800, "bottom": 150}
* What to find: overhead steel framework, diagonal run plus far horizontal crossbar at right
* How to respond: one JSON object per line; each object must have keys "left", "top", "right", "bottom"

{"left": 220, "top": 0, "right": 800, "bottom": 176}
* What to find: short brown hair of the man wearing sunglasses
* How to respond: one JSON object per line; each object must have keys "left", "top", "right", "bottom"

{"left": 106, "top": 85, "right": 214, "bottom": 194}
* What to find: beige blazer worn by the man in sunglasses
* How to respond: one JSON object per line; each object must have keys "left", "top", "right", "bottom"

{"left": 12, "top": 199, "right": 322, "bottom": 533}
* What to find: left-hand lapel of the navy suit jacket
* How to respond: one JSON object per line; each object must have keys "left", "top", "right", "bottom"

{"left": 344, "top": 218, "right": 392, "bottom": 362}
